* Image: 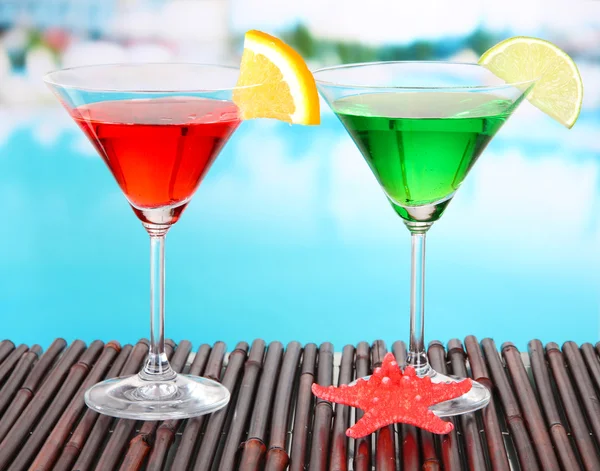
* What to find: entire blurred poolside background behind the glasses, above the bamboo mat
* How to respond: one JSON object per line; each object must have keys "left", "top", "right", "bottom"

{"left": 0, "top": 0, "right": 600, "bottom": 350}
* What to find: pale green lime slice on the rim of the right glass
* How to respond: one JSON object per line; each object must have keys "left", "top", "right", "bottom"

{"left": 479, "top": 36, "right": 583, "bottom": 128}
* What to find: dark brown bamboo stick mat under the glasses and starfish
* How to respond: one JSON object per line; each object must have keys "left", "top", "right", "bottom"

{"left": 0, "top": 336, "right": 600, "bottom": 471}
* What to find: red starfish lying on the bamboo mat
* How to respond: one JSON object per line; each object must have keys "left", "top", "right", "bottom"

{"left": 312, "top": 353, "right": 472, "bottom": 438}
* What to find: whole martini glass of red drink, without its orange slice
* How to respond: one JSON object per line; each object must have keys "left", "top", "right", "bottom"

{"left": 44, "top": 64, "right": 247, "bottom": 420}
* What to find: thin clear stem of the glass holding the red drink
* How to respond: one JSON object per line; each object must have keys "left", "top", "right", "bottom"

{"left": 140, "top": 225, "right": 176, "bottom": 381}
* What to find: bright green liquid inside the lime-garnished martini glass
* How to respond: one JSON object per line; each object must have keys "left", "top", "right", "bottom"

{"left": 332, "top": 92, "right": 516, "bottom": 207}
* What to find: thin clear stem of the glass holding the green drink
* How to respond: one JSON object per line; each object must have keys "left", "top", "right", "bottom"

{"left": 407, "top": 227, "right": 431, "bottom": 376}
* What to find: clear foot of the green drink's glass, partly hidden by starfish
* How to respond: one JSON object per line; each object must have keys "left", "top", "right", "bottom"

{"left": 350, "top": 367, "right": 492, "bottom": 417}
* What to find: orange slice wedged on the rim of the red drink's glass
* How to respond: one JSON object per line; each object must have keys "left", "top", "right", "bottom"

{"left": 233, "top": 30, "right": 321, "bottom": 125}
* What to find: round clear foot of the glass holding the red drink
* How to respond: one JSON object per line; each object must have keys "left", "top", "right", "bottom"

{"left": 85, "top": 374, "right": 230, "bottom": 420}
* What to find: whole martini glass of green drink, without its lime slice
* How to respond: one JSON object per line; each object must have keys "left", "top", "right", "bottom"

{"left": 314, "top": 62, "right": 534, "bottom": 416}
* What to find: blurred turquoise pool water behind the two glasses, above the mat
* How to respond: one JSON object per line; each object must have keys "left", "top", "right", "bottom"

{"left": 0, "top": 107, "right": 600, "bottom": 349}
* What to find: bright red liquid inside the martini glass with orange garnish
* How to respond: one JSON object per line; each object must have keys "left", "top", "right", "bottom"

{"left": 71, "top": 97, "right": 240, "bottom": 222}
